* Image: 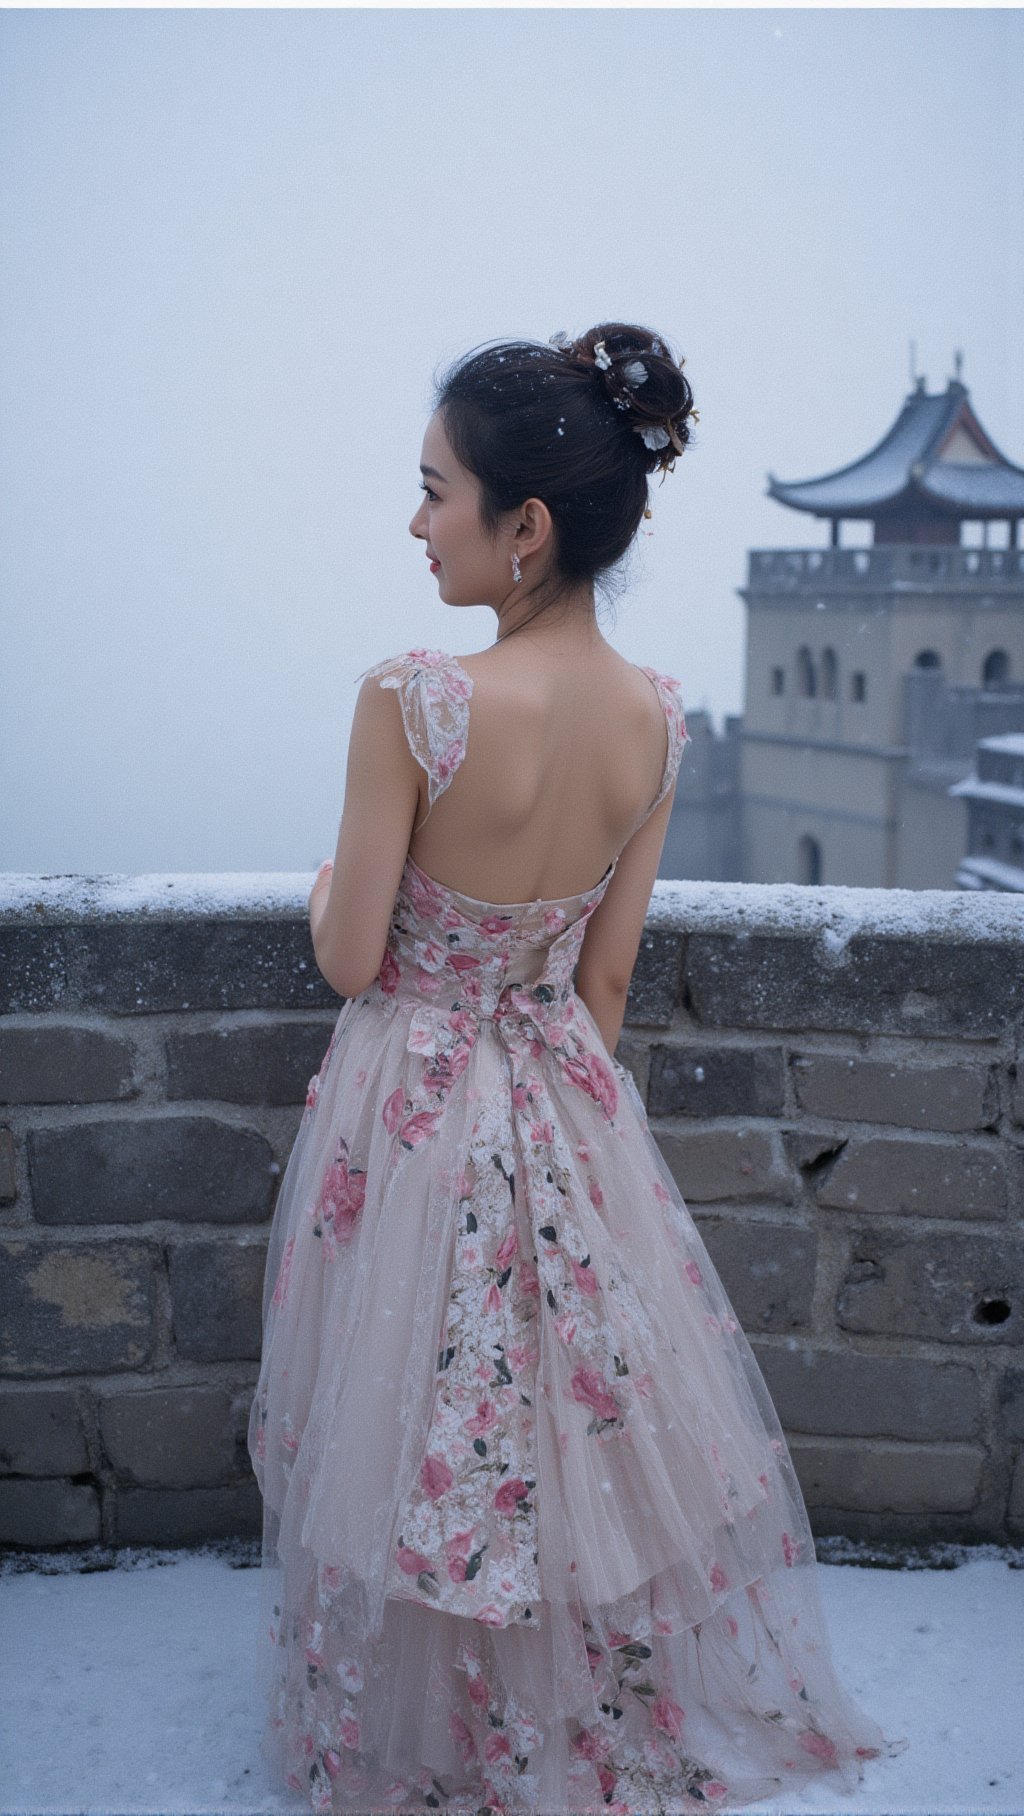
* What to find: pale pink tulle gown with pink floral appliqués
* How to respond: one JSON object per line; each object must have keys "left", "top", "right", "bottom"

{"left": 249, "top": 650, "right": 901, "bottom": 1816}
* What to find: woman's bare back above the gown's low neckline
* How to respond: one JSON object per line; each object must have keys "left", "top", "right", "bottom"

{"left": 409, "top": 639, "right": 666, "bottom": 903}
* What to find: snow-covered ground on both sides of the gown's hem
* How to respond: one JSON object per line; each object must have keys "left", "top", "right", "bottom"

{"left": 0, "top": 1542, "right": 1024, "bottom": 1816}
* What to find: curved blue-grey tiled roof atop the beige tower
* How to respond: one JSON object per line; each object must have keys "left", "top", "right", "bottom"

{"left": 768, "top": 378, "right": 1024, "bottom": 518}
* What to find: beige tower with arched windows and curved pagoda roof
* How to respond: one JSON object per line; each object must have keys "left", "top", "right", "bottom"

{"left": 737, "top": 366, "right": 1024, "bottom": 888}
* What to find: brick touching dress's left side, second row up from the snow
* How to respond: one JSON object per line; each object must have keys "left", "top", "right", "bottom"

{"left": 98, "top": 1386, "right": 236, "bottom": 1487}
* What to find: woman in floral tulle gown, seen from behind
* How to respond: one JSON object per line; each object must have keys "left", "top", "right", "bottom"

{"left": 249, "top": 323, "right": 886, "bottom": 1812}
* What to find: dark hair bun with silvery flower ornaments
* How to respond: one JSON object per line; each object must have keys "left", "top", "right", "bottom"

{"left": 550, "top": 321, "right": 699, "bottom": 472}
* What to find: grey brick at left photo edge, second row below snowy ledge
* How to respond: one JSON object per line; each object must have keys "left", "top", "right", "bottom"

{"left": 0, "top": 1022, "right": 134, "bottom": 1104}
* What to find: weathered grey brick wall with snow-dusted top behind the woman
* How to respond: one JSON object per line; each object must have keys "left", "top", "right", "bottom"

{"left": 0, "top": 873, "right": 1024, "bottom": 1545}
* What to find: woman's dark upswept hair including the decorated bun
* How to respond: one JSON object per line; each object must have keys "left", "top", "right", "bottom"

{"left": 434, "top": 321, "right": 694, "bottom": 617}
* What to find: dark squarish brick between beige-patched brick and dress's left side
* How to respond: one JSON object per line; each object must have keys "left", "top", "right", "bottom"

{"left": 171, "top": 1239, "right": 267, "bottom": 1362}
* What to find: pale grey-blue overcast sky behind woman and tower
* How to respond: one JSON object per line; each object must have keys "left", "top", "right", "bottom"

{"left": 0, "top": 7, "right": 1024, "bottom": 872}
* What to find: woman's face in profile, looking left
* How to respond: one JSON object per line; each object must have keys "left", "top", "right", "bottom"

{"left": 409, "top": 412, "right": 512, "bottom": 605}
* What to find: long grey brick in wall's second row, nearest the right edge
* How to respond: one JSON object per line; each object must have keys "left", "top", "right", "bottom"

{"left": 792, "top": 1053, "right": 997, "bottom": 1133}
